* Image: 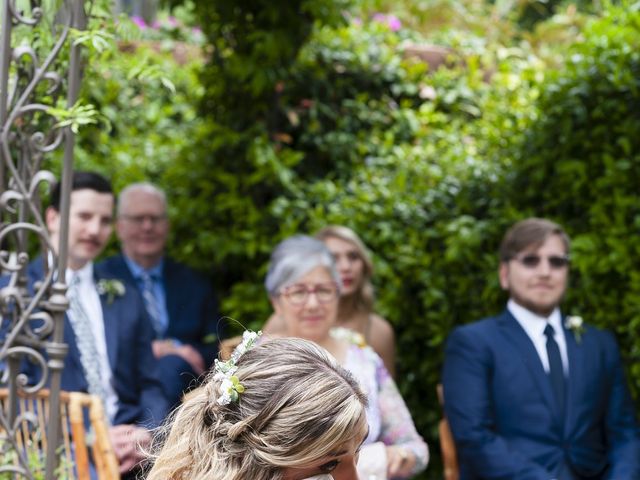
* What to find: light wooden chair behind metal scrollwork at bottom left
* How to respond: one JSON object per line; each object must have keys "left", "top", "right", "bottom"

{"left": 0, "top": 388, "right": 120, "bottom": 480}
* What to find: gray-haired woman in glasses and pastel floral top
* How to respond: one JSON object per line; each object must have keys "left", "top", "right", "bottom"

{"left": 265, "top": 235, "right": 429, "bottom": 480}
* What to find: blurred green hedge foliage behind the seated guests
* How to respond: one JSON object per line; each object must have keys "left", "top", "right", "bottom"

{"left": 66, "top": 0, "right": 640, "bottom": 478}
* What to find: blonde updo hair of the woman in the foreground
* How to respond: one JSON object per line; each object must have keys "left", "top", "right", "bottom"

{"left": 147, "top": 338, "right": 367, "bottom": 480}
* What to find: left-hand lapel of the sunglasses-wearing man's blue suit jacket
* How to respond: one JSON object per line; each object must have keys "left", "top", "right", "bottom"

{"left": 498, "top": 310, "right": 563, "bottom": 424}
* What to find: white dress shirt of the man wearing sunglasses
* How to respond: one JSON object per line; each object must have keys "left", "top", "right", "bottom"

{"left": 507, "top": 300, "right": 569, "bottom": 377}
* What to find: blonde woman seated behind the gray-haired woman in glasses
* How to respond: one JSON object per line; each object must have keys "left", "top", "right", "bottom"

{"left": 264, "top": 225, "right": 396, "bottom": 378}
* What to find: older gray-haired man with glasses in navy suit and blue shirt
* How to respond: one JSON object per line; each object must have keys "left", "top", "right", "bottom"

{"left": 101, "top": 183, "right": 221, "bottom": 403}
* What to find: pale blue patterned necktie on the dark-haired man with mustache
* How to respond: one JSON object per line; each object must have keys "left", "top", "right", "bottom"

{"left": 68, "top": 275, "right": 106, "bottom": 401}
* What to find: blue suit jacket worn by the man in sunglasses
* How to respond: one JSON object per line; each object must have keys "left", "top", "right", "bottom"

{"left": 443, "top": 310, "right": 640, "bottom": 480}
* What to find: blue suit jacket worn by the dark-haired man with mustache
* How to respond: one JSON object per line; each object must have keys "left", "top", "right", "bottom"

{"left": 28, "top": 258, "right": 169, "bottom": 428}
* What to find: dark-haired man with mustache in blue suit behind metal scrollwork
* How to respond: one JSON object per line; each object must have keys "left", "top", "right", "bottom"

{"left": 28, "top": 172, "right": 168, "bottom": 475}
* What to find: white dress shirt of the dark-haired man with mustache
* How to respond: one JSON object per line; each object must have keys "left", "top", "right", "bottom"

{"left": 66, "top": 262, "right": 118, "bottom": 422}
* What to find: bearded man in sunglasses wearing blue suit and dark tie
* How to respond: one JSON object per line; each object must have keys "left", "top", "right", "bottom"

{"left": 443, "top": 218, "right": 640, "bottom": 480}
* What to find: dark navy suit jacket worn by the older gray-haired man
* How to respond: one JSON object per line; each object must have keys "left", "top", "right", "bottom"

{"left": 99, "top": 254, "right": 223, "bottom": 367}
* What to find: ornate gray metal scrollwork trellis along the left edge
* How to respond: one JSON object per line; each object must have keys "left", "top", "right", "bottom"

{"left": 0, "top": 0, "right": 90, "bottom": 479}
